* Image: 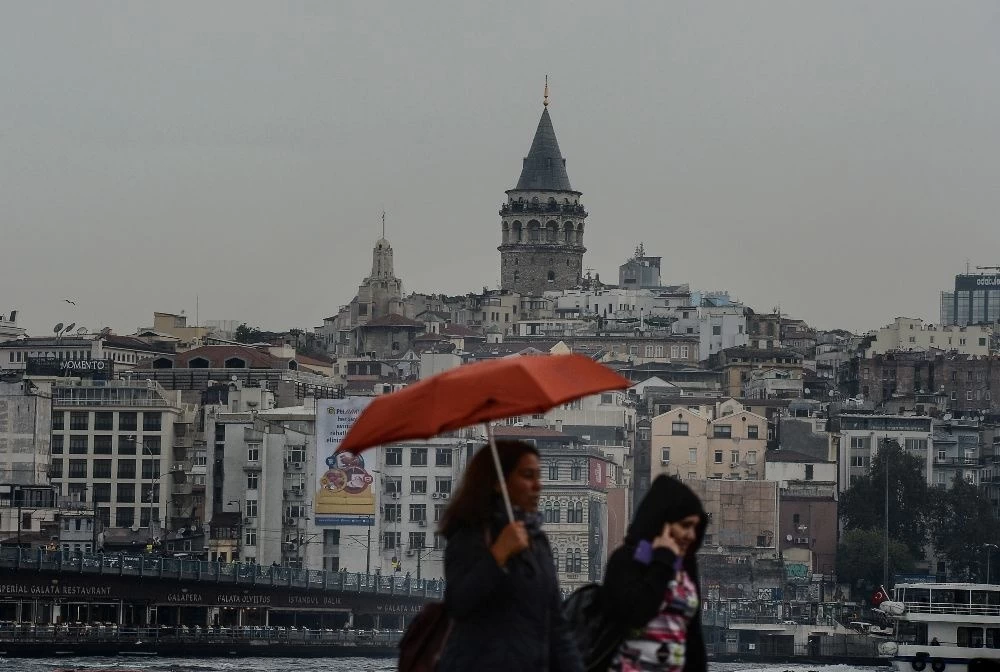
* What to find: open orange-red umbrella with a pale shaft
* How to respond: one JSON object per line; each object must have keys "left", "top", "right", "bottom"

{"left": 337, "top": 355, "right": 631, "bottom": 520}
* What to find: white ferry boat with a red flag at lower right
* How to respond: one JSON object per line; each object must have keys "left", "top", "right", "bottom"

{"left": 878, "top": 583, "right": 1000, "bottom": 672}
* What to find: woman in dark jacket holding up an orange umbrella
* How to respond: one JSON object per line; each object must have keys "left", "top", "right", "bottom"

{"left": 438, "top": 441, "right": 583, "bottom": 672}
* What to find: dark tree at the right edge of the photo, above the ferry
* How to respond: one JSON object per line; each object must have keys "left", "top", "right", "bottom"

{"left": 930, "top": 474, "right": 1000, "bottom": 581}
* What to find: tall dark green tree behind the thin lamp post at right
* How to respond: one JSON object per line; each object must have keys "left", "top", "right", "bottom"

{"left": 840, "top": 440, "right": 932, "bottom": 556}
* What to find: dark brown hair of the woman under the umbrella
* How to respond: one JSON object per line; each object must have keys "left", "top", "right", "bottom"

{"left": 438, "top": 441, "right": 538, "bottom": 537}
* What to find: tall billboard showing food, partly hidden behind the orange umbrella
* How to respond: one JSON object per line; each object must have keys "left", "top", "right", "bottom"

{"left": 313, "top": 397, "right": 378, "bottom": 527}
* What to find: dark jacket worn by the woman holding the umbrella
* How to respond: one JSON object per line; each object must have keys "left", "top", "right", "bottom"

{"left": 438, "top": 520, "right": 582, "bottom": 672}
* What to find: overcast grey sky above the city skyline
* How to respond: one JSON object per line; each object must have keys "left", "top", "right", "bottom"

{"left": 0, "top": 0, "right": 1000, "bottom": 335}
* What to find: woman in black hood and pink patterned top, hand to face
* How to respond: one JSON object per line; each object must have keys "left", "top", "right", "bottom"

{"left": 601, "top": 476, "right": 707, "bottom": 672}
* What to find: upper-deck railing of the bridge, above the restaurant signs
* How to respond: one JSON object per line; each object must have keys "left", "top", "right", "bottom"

{"left": 0, "top": 548, "right": 444, "bottom": 599}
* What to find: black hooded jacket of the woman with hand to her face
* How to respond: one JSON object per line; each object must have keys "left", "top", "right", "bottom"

{"left": 601, "top": 476, "right": 708, "bottom": 672}
